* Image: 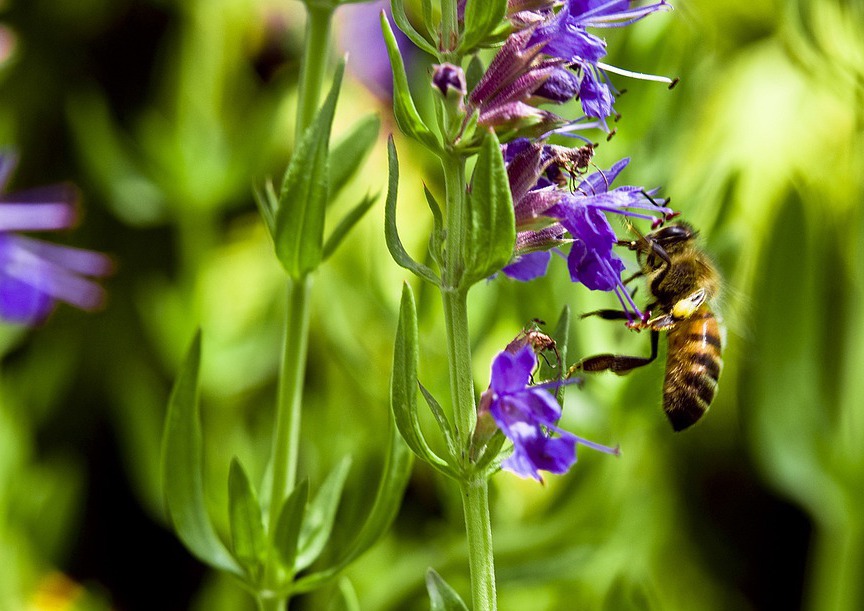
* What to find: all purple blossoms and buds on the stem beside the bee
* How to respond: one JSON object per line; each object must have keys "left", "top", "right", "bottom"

{"left": 456, "top": 0, "right": 675, "bottom": 480}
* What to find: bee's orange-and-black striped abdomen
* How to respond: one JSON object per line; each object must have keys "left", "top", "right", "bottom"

{"left": 663, "top": 306, "right": 723, "bottom": 431}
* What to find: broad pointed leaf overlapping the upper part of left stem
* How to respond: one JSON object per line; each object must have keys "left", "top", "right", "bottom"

{"left": 273, "top": 61, "right": 345, "bottom": 280}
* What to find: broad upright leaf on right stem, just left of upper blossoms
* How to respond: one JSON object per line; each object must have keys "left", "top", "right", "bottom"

{"left": 463, "top": 130, "right": 516, "bottom": 286}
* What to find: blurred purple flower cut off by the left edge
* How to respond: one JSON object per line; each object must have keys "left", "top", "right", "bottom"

{"left": 0, "top": 153, "right": 113, "bottom": 324}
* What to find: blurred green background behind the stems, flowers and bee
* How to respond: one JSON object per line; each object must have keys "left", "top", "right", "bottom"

{"left": 0, "top": 0, "right": 864, "bottom": 610}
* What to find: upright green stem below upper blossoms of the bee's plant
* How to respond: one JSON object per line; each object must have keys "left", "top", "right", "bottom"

{"left": 442, "top": 149, "right": 496, "bottom": 611}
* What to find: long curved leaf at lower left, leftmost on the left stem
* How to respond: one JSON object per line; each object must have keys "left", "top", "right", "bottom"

{"left": 162, "top": 333, "right": 243, "bottom": 576}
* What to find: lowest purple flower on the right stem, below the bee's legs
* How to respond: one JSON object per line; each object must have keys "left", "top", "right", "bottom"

{"left": 481, "top": 343, "right": 618, "bottom": 481}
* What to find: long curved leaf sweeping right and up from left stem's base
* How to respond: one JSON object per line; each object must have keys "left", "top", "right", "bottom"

{"left": 291, "top": 412, "right": 414, "bottom": 594}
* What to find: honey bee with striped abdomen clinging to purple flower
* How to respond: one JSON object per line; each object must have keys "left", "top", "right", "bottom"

{"left": 571, "top": 222, "right": 723, "bottom": 431}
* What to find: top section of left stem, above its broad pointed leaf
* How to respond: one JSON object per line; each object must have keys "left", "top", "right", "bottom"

{"left": 295, "top": 5, "right": 333, "bottom": 142}
